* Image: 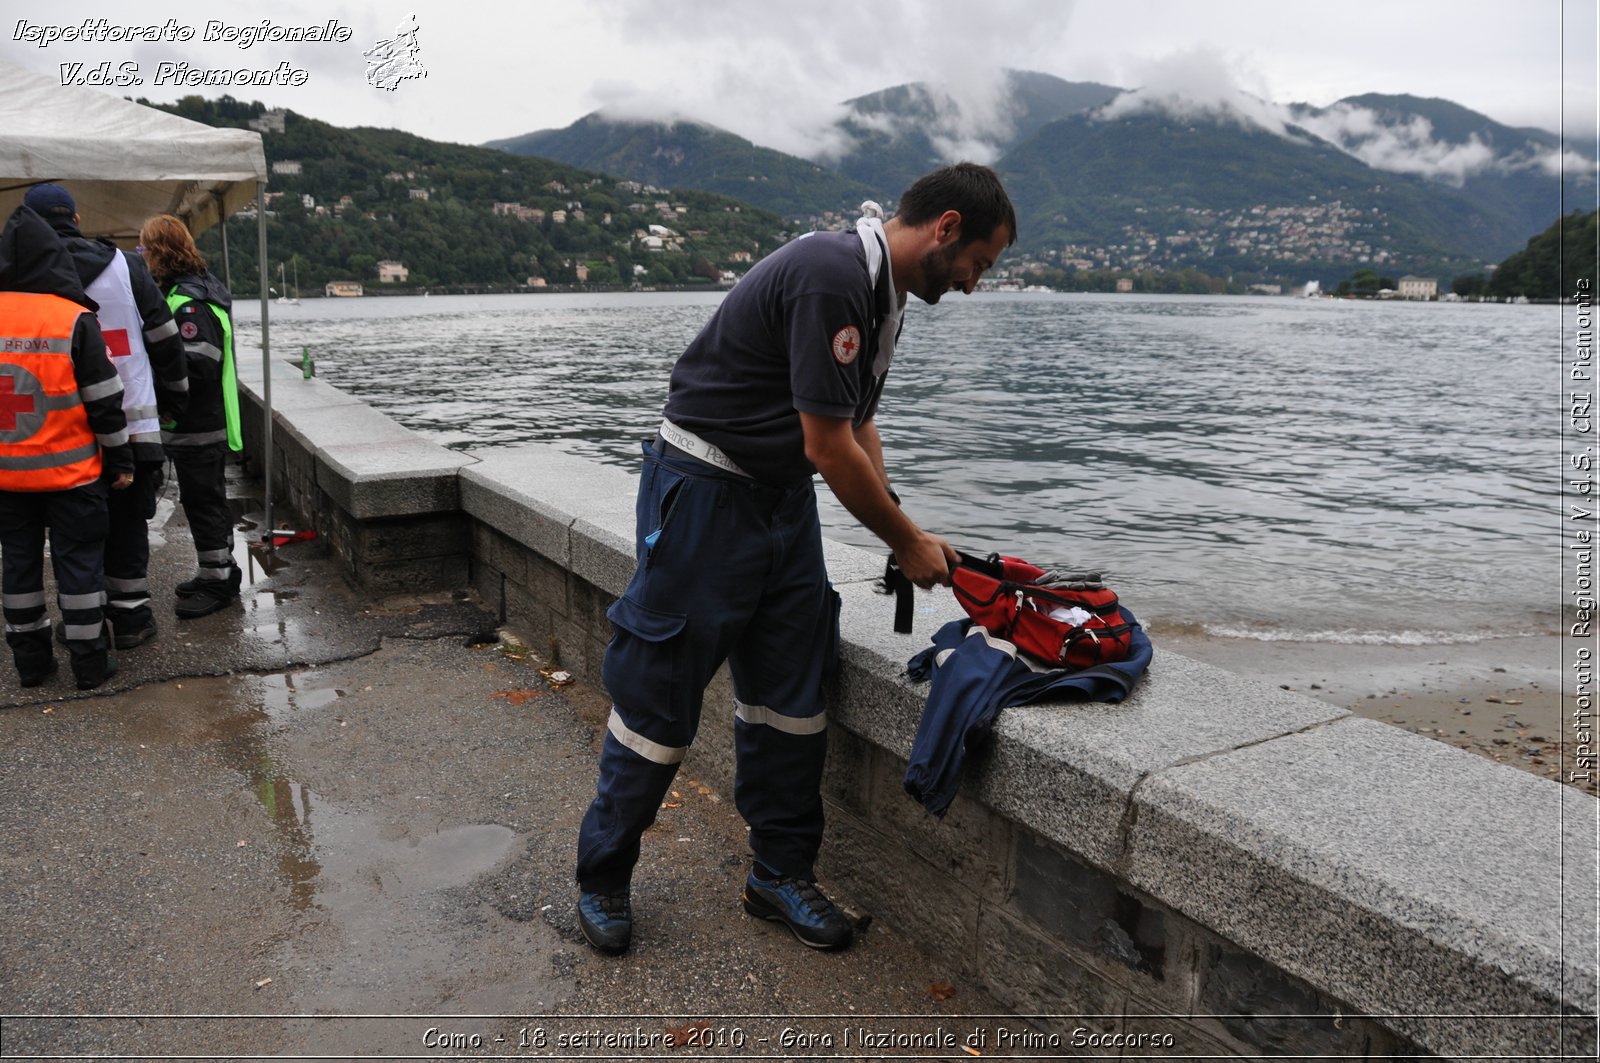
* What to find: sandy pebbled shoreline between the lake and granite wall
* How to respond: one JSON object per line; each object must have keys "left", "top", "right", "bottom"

{"left": 1150, "top": 629, "right": 1600, "bottom": 796}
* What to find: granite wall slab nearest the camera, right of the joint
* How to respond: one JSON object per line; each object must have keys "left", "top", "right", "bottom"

{"left": 1126, "top": 717, "right": 1597, "bottom": 1050}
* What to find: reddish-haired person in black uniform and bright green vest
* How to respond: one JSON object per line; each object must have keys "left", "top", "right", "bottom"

{"left": 139, "top": 215, "right": 243, "bottom": 620}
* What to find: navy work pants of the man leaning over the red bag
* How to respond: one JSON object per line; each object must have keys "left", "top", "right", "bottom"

{"left": 578, "top": 443, "right": 838, "bottom": 892}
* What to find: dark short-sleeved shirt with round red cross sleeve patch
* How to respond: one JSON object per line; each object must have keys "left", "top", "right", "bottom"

{"left": 664, "top": 232, "right": 893, "bottom": 483}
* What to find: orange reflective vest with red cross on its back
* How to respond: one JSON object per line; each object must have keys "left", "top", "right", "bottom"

{"left": 0, "top": 291, "right": 101, "bottom": 491}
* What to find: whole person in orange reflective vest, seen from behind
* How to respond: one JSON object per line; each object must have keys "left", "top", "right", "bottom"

{"left": 0, "top": 207, "right": 133, "bottom": 690}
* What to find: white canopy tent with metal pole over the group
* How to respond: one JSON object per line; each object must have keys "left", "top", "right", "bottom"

{"left": 0, "top": 62, "right": 283, "bottom": 548}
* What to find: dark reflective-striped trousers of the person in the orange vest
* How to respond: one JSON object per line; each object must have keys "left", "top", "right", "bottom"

{"left": 0, "top": 480, "right": 110, "bottom": 676}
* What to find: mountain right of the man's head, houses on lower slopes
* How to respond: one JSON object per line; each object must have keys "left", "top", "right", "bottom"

{"left": 997, "top": 112, "right": 1525, "bottom": 275}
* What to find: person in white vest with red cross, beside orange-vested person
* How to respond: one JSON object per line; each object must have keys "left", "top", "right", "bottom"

{"left": 22, "top": 184, "right": 189, "bottom": 650}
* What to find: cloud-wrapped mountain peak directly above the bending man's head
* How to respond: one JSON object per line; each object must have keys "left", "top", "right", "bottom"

{"left": 834, "top": 70, "right": 1123, "bottom": 199}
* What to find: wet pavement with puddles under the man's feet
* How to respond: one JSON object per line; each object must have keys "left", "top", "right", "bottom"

{"left": 0, "top": 467, "right": 1004, "bottom": 1060}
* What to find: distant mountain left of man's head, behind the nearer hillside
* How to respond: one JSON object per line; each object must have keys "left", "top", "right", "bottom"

{"left": 486, "top": 112, "right": 880, "bottom": 216}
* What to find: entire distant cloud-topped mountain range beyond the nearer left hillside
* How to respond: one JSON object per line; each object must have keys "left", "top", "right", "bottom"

{"left": 480, "top": 70, "right": 1594, "bottom": 280}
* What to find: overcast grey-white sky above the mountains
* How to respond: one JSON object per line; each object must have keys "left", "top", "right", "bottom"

{"left": 3, "top": 0, "right": 1597, "bottom": 154}
